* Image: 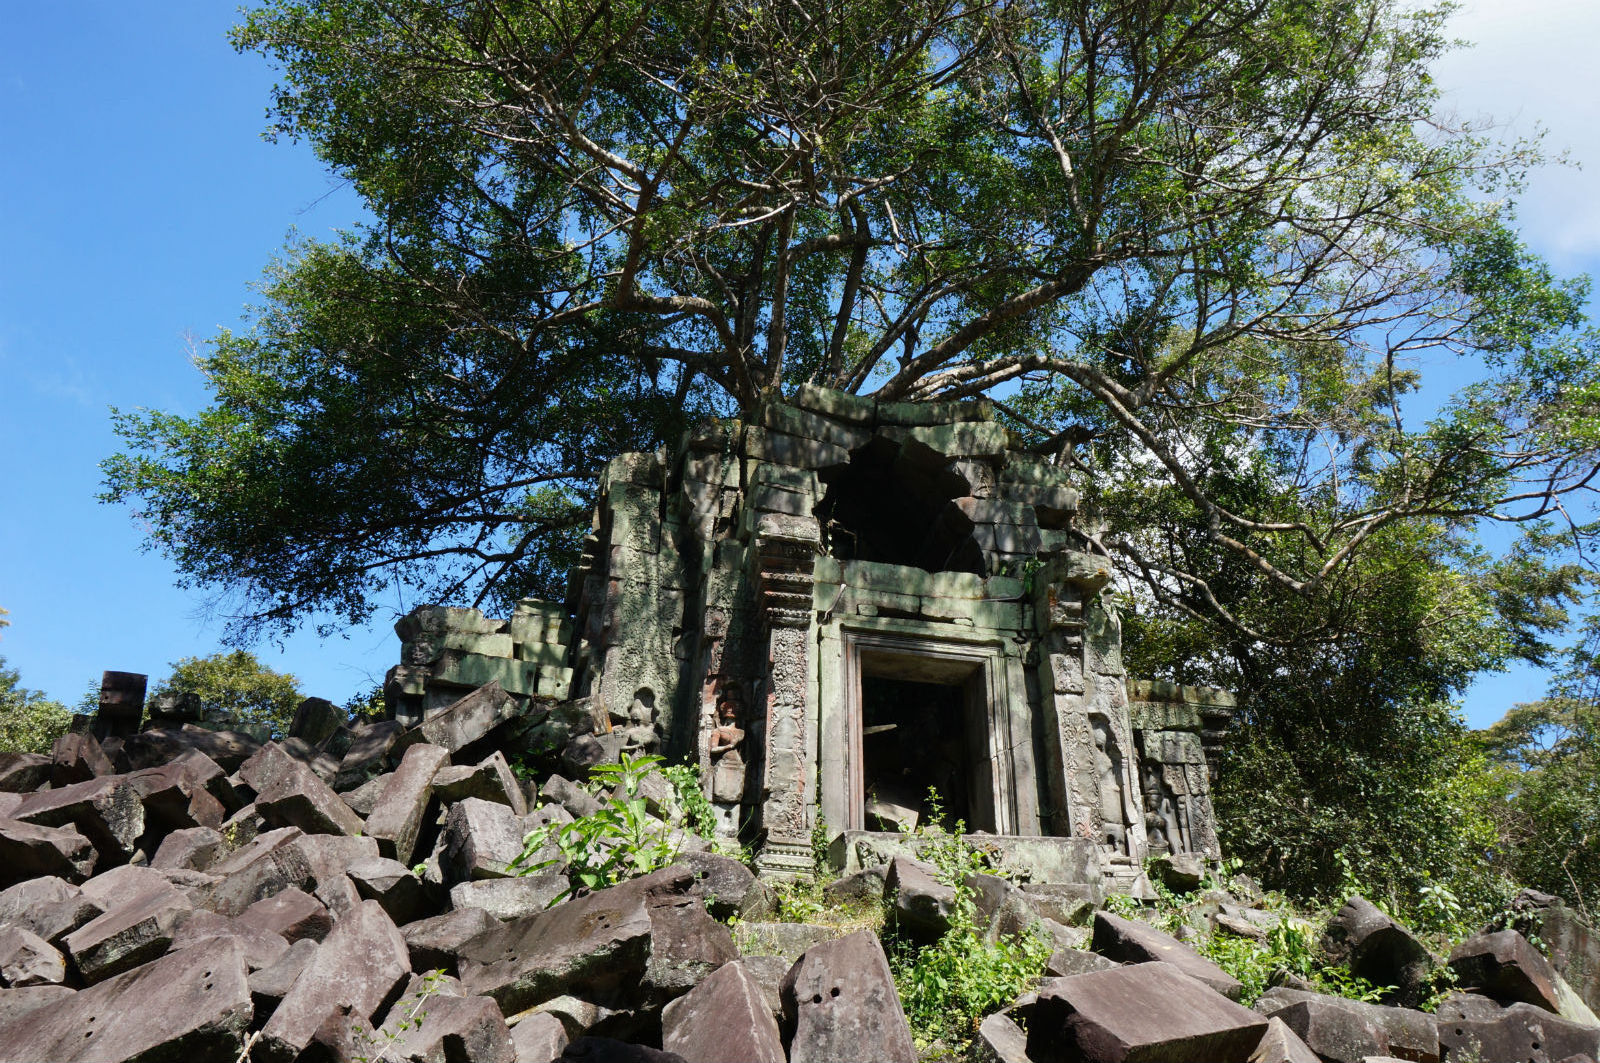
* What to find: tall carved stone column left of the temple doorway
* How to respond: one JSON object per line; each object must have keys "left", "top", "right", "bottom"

{"left": 752, "top": 514, "right": 819, "bottom": 877}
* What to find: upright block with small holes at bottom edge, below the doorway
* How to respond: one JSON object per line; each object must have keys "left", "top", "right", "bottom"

{"left": 781, "top": 930, "right": 917, "bottom": 1063}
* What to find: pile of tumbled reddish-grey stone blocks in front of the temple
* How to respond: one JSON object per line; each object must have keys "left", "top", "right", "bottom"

{"left": 0, "top": 684, "right": 1600, "bottom": 1063}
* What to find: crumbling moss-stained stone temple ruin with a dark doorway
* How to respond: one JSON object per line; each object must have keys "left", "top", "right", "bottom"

{"left": 386, "top": 386, "right": 1232, "bottom": 887}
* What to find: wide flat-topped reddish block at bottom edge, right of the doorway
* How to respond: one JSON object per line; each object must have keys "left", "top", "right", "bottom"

{"left": 1027, "top": 962, "right": 1267, "bottom": 1063}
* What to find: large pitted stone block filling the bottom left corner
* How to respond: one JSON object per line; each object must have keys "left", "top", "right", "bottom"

{"left": 0, "top": 938, "right": 251, "bottom": 1061}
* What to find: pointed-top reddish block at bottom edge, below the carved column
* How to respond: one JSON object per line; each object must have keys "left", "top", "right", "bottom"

{"left": 661, "top": 962, "right": 786, "bottom": 1063}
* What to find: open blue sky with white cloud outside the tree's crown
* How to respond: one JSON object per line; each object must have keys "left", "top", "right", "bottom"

{"left": 0, "top": 0, "right": 1600, "bottom": 725}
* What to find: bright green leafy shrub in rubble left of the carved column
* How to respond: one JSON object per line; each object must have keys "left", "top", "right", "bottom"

{"left": 510, "top": 752, "right": 678, "bottom": 905}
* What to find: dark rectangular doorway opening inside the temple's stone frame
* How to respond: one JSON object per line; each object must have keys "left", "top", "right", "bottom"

{"left": 861, "top": 676, "right": 979, "bottom": 831}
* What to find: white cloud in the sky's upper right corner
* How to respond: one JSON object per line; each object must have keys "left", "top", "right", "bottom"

{"left": 1435, "top": 0, "right": 1600, "bottom": 271}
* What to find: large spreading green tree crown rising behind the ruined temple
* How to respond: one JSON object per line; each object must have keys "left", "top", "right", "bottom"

{"left": 107, "top": 0, "right": 1600, "bottom": 644}
